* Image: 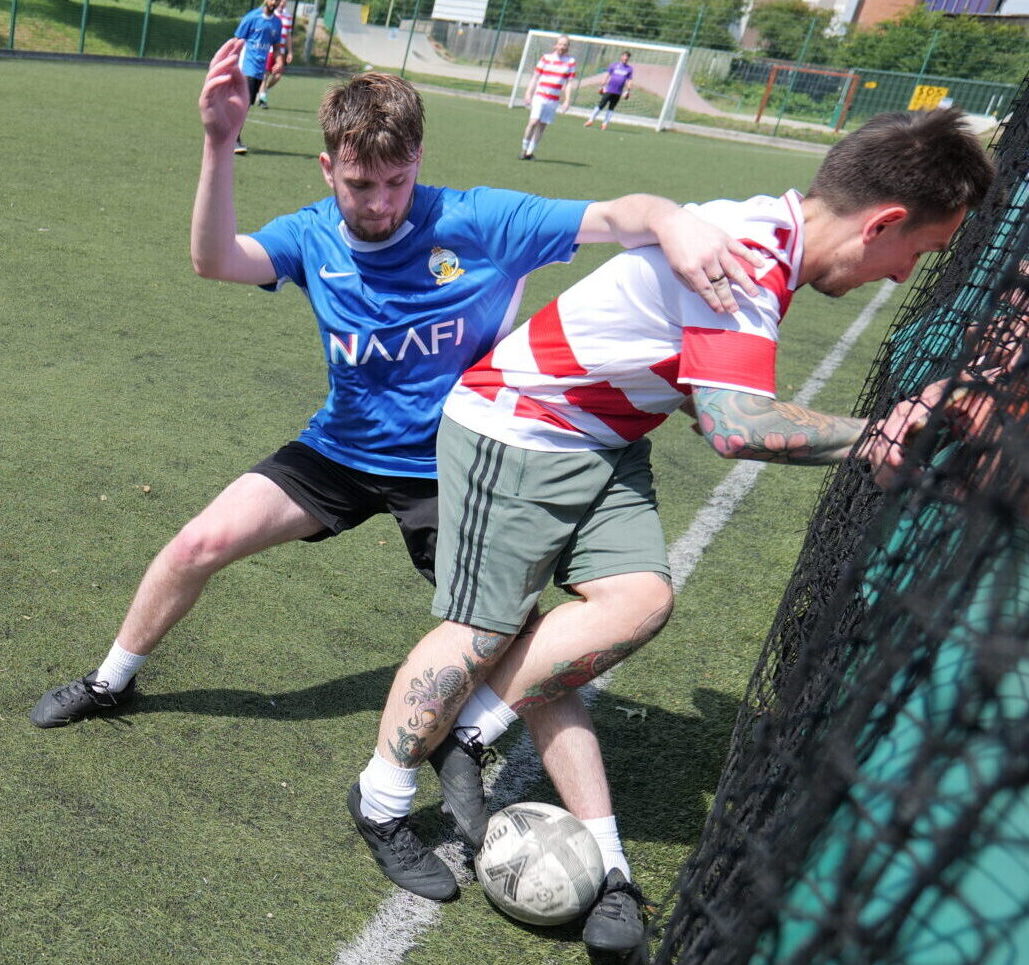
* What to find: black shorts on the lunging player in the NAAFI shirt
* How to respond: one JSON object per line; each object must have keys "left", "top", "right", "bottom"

{"left": 250, "top": 441, "right": 438, "bottom": 585}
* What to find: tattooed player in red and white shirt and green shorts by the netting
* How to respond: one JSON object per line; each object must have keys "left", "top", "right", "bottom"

{"left": 352, "top": 111, "right": 992, "bottom": 952}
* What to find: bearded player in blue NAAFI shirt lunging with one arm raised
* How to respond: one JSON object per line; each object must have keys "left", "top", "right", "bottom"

{"left": 31, "top": 28, "right": 755, "bottom": 942}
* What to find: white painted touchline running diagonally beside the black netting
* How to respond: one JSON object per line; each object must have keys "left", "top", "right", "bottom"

{"left": 333, "top": 281, "right": 896, "bottom": 965}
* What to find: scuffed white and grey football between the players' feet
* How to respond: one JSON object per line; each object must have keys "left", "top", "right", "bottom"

{"left": 475, "top": 803, "right": 604, "bottom": 925}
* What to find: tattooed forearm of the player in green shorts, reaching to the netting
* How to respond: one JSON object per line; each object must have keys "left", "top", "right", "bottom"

{"left": 690, "top": 387, "right": 865, "bottom": 466}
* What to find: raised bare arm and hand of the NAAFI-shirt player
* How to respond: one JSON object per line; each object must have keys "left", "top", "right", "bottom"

{"left": 189, "top": 39, "right": 275, "bottom": 285}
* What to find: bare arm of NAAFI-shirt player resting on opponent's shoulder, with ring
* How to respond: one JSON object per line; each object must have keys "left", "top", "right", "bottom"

{"left": 575, "top": 194, "right": 762, "bottom": 312}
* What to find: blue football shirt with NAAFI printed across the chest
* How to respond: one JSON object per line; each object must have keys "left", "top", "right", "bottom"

{"left": 247, "top": 185, "right": 589, "bottom": 477}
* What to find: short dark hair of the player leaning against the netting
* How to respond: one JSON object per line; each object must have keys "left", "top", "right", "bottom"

{"left": 808, "top": 108, "right": 994, "bottom": 229}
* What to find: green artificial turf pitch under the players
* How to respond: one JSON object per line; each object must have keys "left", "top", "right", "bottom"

{"left": 0, "top": 59, "right": 890, "bottom": 965}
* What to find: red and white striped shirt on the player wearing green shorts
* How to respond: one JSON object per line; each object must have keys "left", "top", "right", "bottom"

{"left": 443, "top": 191, "right": 804, "bottom": 452}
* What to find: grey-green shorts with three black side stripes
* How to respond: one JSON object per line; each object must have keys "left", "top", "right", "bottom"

{"left": 432, "top": 417, "right": 670, "bottom": 634}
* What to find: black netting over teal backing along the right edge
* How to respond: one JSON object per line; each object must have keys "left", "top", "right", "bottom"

{"left": 654, "top": 77, "right": 1029, "bottom": 965}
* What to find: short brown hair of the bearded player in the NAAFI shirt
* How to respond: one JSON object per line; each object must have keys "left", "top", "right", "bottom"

{"left": 318, "top": 71, "right": 425, "bottom": 169}
